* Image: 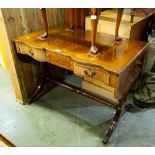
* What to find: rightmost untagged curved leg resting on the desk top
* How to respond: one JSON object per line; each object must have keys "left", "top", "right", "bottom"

{"left": 115, "top": 8, "right": 124, "bottom": 41}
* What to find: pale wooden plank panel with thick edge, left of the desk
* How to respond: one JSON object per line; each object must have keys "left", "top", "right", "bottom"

{"left": 0, "top": 8, "right": 63, "bottom": 103}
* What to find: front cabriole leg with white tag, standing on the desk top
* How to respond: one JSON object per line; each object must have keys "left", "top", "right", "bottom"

{"left": 90, "top": 8, "right": 98, "bottom": 55}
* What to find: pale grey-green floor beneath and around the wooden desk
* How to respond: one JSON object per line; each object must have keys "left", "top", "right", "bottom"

{"left": 0, "top": 64, "right": 155, "bottom": 146}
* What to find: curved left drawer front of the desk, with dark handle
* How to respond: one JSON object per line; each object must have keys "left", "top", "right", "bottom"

{"left": 16, "top": 43, "right": 46, "bottom": 62}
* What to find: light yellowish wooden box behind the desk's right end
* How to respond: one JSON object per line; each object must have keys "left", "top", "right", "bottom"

{"left": 85, "top": 9, "right": 153, "bottom": 41}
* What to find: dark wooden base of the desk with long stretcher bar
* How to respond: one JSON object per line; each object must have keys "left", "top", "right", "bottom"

{"left": 22, "top": 62, "right": 132, "bottom": 144}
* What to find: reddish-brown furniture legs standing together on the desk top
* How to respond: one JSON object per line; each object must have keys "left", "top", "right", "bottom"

{"left": 40, "top": 8, "right": 123, "bottom": 56}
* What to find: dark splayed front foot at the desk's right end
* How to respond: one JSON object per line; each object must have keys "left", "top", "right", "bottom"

{"left": 102, "top": 109, "right": 122, "bottom": 144}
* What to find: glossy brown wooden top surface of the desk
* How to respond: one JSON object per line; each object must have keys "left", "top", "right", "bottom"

{"left": 14, "top": 26, "right": 148, "bottom": 74}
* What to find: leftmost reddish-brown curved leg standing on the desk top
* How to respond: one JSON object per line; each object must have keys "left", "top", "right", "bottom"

{"left": 39, "top": 8, "right": 48, "bottom": 40}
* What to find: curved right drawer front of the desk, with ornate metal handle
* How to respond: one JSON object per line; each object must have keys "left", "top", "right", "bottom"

{"left": 74, "top": 63, "right": 110, "bottom": 85}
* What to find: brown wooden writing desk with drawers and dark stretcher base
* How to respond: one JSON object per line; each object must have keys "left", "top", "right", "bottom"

{"left": 14, "top": 26, "right": 148, "bottom": 143}
